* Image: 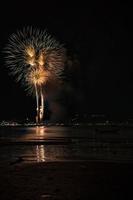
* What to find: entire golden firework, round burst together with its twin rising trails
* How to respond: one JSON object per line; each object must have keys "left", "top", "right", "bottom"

{"left": 5, "top": 27, "right": 65, "bottom": 122}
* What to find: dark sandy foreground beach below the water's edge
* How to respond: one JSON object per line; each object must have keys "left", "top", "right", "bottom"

{"left": 0, "top": 161, "right": 133, "bottom": 200}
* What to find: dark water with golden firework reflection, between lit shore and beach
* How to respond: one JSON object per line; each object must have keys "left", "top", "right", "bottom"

{"left": 0, "top": 126, "right": 133, "bottom": 162}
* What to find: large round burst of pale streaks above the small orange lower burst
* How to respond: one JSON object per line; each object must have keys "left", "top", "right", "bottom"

{"left": 5, "top": 27, "right": 65, "bottom": 89}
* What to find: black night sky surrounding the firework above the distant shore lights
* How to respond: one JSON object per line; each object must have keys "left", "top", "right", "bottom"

{"left": 0, "top": 1, "right": 133, "bottom": 119}
